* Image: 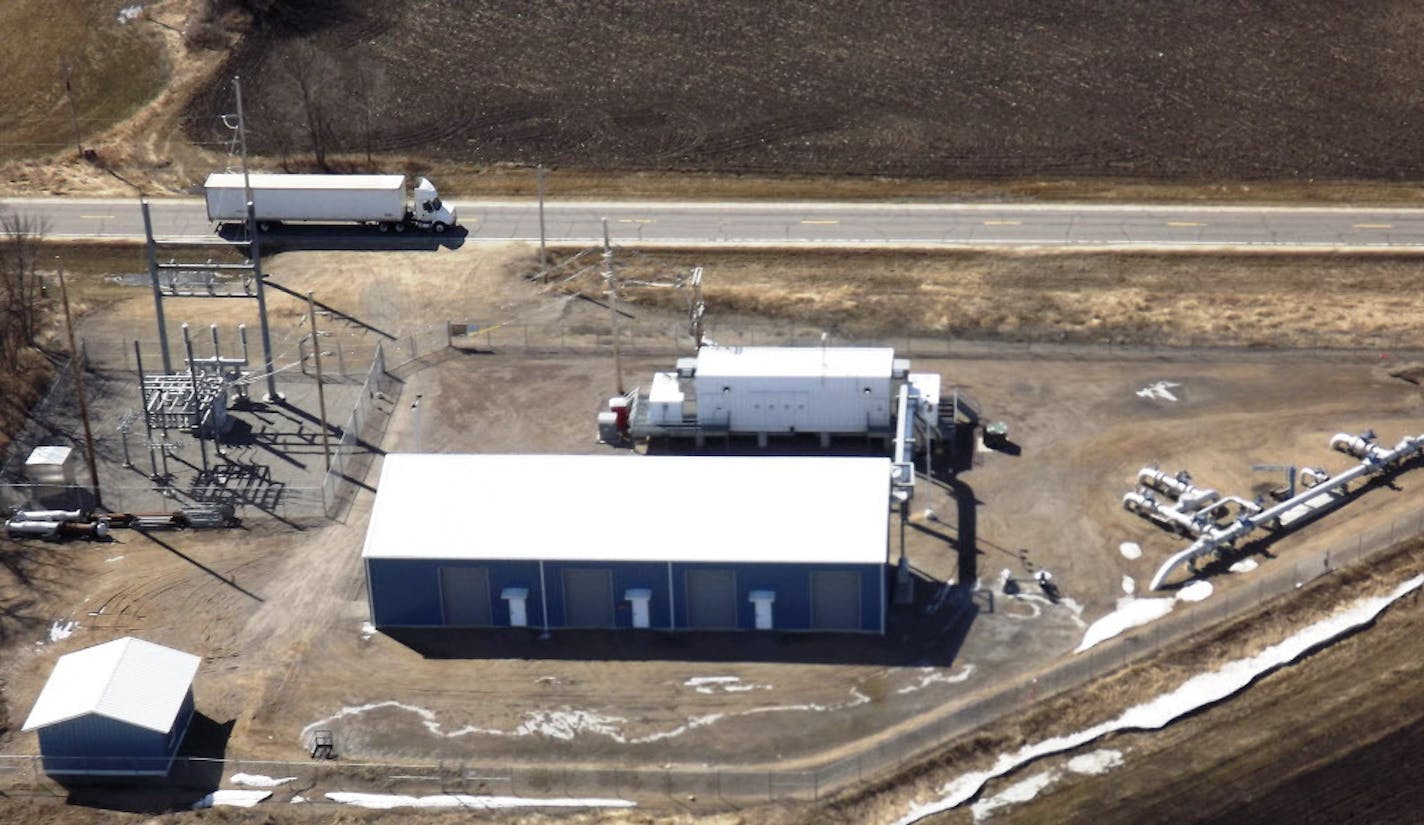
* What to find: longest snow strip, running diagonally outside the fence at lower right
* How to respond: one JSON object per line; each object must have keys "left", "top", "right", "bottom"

{"left": 896, "top": 574, "right": 1424, "bottom": 825}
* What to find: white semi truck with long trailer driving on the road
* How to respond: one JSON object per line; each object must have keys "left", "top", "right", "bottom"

{"left": 204, "top": 172, "right": 456, "bottom": 232}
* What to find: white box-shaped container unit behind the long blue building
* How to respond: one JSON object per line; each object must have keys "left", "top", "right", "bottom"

{"left": 693, "top": 346, "right": 903, "bottom": 433}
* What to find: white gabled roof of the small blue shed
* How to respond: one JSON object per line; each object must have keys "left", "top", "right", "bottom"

{"left": 24, "top": 635, "right": 202, "bottom": 732}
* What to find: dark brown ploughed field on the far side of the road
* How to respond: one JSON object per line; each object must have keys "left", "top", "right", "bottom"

{"left": 191, "top": 0, "right": 1424, "bottom": 181}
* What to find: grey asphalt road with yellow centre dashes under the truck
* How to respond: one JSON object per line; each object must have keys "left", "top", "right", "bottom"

{"left": 0, "top": 198, "right": 1424, "bottom": 249}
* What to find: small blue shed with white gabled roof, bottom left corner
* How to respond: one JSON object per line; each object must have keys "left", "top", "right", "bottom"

{"left": 24, "top": 637, "right": 202, "bottom": 778}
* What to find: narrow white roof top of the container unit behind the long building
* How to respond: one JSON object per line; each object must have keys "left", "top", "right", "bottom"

{"left": 696, "top": 346, "right": 894, "bottom": 379}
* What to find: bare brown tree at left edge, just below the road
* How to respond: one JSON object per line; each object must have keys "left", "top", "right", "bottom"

{"left": 0, "top": 212, "right": 48, "bottom": 369}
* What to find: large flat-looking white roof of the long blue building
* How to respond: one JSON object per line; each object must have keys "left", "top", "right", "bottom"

{"left": 362, "top": 453, "right": 890, "bottom": 564}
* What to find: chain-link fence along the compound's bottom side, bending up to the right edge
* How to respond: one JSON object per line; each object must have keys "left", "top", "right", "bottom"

{"left": 0, "top": 509, "right": 1424, "bottom": 805}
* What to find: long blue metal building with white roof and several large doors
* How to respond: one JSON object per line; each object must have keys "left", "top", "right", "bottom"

{"left": 363, "top": 455, "right": 890, "bottom": 633}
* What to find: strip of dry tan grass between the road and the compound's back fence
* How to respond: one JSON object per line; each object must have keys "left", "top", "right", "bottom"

{"left": 584, "top": 249, "right": 1424, "bottom": 349}
